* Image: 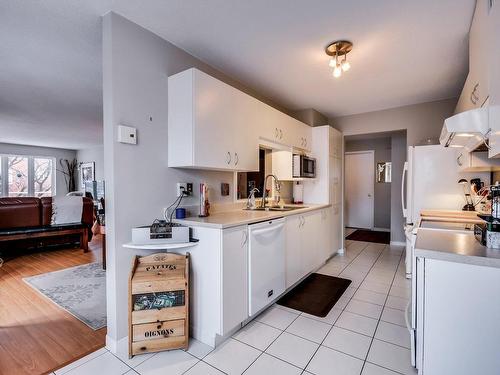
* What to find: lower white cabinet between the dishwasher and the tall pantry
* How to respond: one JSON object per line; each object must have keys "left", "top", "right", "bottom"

{"left": 285, "top": 209, "right": 330, "bottom": 288}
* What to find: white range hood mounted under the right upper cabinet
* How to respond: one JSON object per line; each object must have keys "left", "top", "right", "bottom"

{"left": 439, "top": 107, "right": 489, "bottom": 151}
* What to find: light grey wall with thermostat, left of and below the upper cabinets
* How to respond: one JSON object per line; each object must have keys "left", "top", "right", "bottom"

{"left": 103, "top": 13, "right": 304, "bottom": 351}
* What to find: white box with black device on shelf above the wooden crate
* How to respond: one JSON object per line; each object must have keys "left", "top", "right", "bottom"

{"left": 132, "top": 219, "right": 190, "bottom": 245}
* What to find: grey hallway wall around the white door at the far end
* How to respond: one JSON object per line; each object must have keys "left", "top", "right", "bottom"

{"left": 344, "top": 137, "right": 397, "bottom": 229}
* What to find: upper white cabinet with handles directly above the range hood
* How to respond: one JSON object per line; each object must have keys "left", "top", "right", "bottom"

{"left": 455, "top": 0, "right": 492, "bottom": 113}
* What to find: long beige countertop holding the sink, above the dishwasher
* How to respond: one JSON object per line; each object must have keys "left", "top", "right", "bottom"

{"left": 174, "top": 204, "right": 331, "bottom": 229}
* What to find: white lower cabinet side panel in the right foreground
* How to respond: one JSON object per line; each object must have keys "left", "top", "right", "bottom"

{"left": 417, "top": 258, "right": 500, "bottom": 375}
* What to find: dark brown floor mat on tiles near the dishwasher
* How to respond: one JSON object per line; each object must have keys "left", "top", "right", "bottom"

{"left": 277, "top": 273, "right": 351, "bottom": 318}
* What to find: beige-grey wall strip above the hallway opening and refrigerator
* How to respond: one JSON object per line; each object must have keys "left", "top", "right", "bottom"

{"left": 330, "top": 98, "right": 457, "bottom": 146}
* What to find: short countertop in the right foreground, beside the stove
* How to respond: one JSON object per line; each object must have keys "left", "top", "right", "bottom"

{"left": 415, "top": 229, "right": 500, "bottom": 268}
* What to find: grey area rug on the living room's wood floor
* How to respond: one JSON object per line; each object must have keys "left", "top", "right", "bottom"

{"left": 23, "top": 263, "right": 106, "bottom": 330}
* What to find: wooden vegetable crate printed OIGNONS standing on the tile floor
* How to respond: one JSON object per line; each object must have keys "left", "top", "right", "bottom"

{"left": 128, "top": 253, "right": 189, "bottom": 358}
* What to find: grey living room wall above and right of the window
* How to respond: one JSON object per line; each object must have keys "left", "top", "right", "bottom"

{"left": 0, "top": 143, "right": 76, "bottom": 195}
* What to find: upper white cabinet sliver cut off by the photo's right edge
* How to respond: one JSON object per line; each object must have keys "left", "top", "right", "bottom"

{"left": 488, "top": 0, "right": 500, "bottom": 158}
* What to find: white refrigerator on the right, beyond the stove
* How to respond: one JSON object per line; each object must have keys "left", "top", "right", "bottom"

{"left": 401, "top": 145, "right": 490, "bottom": 278}
